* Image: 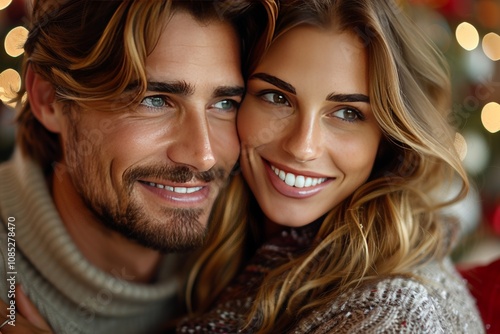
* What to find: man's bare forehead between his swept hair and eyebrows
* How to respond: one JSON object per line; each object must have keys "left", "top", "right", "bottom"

{"left": 146, "top": 12, "right": 243, "bottom": 91}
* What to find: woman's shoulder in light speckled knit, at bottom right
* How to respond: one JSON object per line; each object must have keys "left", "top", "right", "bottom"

{"left": 292, "top": 261, "right": 484, "bottom": 333}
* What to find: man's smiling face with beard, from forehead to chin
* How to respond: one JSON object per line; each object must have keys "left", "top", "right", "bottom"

{"left": 54, "top": 12, "right": 243, "bottom": 251}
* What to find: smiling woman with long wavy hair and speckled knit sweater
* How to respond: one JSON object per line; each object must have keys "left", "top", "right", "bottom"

{"left": 178, "top": 0, "right": 484, "bottom": 333}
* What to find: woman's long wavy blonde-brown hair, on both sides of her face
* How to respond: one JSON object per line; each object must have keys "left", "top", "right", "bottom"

{"left": 188, "top": 0, "right": 469, "bottom": 332}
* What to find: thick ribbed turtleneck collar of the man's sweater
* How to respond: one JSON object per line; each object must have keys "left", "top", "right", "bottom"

{"left": 0, "top": 150, "right": 183, "bottom": 315}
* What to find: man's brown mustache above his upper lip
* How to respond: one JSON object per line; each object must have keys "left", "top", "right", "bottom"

{"left": 123, "top": 165, "right": 227, "bottom": 184}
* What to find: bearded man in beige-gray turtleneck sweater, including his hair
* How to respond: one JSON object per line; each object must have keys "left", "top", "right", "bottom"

{"left": 0, "top": 0, "right": 274, "bottom": 333}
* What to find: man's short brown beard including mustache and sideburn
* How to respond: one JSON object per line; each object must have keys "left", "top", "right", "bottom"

{"left": 65, "top": 116, "right": 226, "bottom": 252}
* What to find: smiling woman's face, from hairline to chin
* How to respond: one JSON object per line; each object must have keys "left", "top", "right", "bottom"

{"left": 238, "top": 26, "right": 381, "bottom": 227}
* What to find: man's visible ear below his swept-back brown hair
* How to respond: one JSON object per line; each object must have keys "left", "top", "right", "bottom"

{"left": 25, "top": 65, "right": 61, "bottom": 133}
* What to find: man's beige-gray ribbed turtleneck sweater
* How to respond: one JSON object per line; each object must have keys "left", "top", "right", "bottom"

{"left": 0, "top": 152, "right": 184, "bottom": 334}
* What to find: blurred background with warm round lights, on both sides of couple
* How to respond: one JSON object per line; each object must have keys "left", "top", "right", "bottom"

{"left": 0, "top": 0, "right": 500, "bottom": 266}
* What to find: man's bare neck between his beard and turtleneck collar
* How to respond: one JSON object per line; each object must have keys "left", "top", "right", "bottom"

{"left": 52, "top": 173, "right": 161, "bottom": 283}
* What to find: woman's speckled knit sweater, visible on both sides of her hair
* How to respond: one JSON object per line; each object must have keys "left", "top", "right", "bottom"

{"left": 178, "top": 224, "right": 484, "bottom": 334}
